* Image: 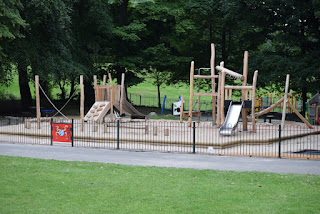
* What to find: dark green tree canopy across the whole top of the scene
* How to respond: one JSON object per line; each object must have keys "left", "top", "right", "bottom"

{"left": 0, "top": 0, "right": 320, "bottom": 113}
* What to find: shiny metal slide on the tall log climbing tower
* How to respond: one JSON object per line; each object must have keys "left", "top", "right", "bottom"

{"left": 219, "top": 101, "right": 243, "bottom": 135}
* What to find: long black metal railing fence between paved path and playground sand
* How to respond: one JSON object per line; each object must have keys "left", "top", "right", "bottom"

{"left": 0, "top": 117, "right": 320, "bottom": 159}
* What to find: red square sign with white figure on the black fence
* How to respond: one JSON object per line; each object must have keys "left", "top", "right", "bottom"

{"left": 51, "top": 123, "right": 73, "bottom": 143}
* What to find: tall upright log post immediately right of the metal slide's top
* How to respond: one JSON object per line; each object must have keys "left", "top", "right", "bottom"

{"left": 241, "top": 51, "right": 249, "bottom": 131}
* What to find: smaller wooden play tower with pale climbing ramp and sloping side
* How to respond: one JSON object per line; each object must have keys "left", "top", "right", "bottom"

{"left": 84, "top": 73, "right": 146, "bottom": 123}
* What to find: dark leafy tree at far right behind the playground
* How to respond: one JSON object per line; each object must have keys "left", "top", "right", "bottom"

{"left": 253, "top": 0, "right": 320, "bottom": 113}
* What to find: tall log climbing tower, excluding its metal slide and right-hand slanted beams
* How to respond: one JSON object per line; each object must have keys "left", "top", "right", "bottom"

{"left": 180, "top": 44, "right": 258, "bottom": 132}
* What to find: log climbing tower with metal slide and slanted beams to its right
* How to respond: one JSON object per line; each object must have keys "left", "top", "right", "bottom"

{"left": 180, "top": 44, "right": 312, "bottom": 135}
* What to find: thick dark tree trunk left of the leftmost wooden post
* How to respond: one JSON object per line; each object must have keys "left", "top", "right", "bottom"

{"left": 18, "top": 60, "right": 32, "bottom": 109}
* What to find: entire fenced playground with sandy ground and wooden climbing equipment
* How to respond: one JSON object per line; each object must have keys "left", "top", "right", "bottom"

{"left": 0, "top": 44, "right": 320, "bottom": 158}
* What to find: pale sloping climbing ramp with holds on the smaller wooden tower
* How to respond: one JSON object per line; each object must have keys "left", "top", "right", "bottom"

{"left": 84, "top": 101, "right": 110, "bottom": 122}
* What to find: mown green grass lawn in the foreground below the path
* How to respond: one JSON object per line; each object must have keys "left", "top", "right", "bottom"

{"left": 0, "top": 156, "right": 320, "bottom": 213}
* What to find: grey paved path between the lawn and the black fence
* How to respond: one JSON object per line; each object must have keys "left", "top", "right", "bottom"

{"left": 0, "top": 143, "right": 320, "bottom": 175}
